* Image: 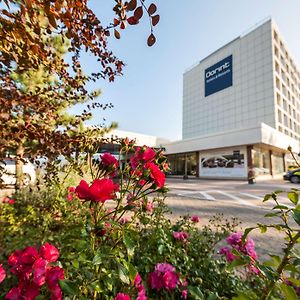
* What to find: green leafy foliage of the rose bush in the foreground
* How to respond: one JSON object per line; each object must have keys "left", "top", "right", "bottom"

{"left": 0, "top": 145, "right": 300, "bottom": 300}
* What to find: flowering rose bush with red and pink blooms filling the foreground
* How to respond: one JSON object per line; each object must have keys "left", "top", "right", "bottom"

{"left": 0, "top": 139, "right": 299, "bottom": 300}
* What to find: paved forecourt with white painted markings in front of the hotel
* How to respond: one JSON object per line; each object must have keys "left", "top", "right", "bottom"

{"left": 166, "top": 178, "right": 300, "bottom": 259}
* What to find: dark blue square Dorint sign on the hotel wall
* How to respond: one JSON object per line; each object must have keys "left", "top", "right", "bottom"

{"left": 204, "top": 55, "right": 232, "bottom": 97}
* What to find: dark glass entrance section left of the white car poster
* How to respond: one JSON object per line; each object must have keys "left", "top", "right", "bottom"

{"left": 167, "top": 152, "right": 198, "bottom": 176}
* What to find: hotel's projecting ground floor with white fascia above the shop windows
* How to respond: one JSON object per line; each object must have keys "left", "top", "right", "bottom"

{"left": 165, "top": 123, "right": 300, "bottom": 180}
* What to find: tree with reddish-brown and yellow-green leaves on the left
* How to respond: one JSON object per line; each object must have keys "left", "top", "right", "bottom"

{"left": 0, "top": 0, "right": 159, "bottom": 188}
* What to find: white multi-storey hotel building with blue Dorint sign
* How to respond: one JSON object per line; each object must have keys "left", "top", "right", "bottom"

{"left": 165, "top": 19, "right": 300, "bottom": 178}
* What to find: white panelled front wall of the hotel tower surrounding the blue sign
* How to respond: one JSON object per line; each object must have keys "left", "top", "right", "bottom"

{"left": 182, "top": 20, "right": 275, "bottom": 139}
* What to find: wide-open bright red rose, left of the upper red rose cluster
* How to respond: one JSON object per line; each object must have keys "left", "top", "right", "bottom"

{"left": 75, "top": 178, "right": 119, "bottom": 203}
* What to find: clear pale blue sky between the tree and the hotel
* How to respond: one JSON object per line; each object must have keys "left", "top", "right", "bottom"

{"left": 72, "top": 0, "right": 300, "bottom": 140}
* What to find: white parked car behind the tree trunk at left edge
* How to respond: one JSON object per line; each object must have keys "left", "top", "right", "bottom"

{"left": 0, "top": 158, "right": 36, "bottom": 186}
